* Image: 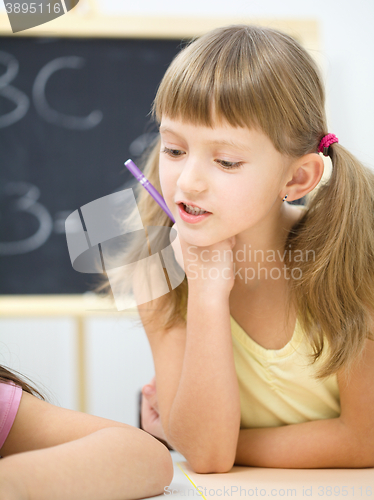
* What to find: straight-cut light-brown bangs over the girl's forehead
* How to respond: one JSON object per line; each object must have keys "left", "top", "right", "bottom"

{"left": 152, "top": 27, "right": 258, "bottom": 128}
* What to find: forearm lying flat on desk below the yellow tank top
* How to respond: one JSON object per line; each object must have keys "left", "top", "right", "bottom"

{"left": 235, "top": 418, "right": 373, "bottom": 469}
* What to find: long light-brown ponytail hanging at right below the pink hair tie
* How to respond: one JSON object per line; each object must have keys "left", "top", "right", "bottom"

{"left": 286, "top": 144, "right": 374, "bottom": 379}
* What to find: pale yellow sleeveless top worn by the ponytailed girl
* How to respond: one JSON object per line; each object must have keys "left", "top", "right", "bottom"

{"left": 230, "top": 316, "right": 340, "bottom": 429}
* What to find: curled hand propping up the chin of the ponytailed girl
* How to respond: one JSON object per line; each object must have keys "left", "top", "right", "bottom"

{"left": 172, "top": 224, "right": 236, "bottom": 292}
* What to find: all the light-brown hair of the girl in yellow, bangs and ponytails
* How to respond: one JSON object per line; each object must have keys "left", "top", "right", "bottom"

{"left": 101, "top": 25, "right": 374, "bottom": 378}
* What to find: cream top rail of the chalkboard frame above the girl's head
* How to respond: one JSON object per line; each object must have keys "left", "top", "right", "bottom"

{"left": 0, "top": 10, "right": 320, "bottom": 52}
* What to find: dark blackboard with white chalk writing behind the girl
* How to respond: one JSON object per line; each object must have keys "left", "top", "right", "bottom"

{"left": 0, "top": 37, "right": 183, "bottom": 294}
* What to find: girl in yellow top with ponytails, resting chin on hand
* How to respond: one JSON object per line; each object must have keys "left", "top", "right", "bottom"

{"left": 117, "top": 25, "right": 374, "bottom": 473}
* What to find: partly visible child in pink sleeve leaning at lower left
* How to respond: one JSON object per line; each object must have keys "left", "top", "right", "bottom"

{"left": 0, "top": 366, "right": 173, "bottom": 500}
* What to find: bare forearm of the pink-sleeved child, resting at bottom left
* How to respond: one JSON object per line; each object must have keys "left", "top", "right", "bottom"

{"left": 0, "top": 427, "right": 172, "bottom": 500}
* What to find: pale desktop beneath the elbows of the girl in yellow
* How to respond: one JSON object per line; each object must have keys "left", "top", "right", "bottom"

{"left": 148, "top": 452, "right": 374, "bottom": 500}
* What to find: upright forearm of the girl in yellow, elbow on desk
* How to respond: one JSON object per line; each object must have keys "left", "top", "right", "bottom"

{"left": 166, "top": 291, "right": 240, "bottom": 472}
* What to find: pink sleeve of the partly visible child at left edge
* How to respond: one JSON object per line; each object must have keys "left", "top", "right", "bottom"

{"left": 0, "top": 381, "right": 22, "bottom": 451}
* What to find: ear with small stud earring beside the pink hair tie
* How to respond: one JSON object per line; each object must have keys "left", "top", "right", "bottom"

{"left": 280, "top": 153, "right": 324, "bottom": 201}
